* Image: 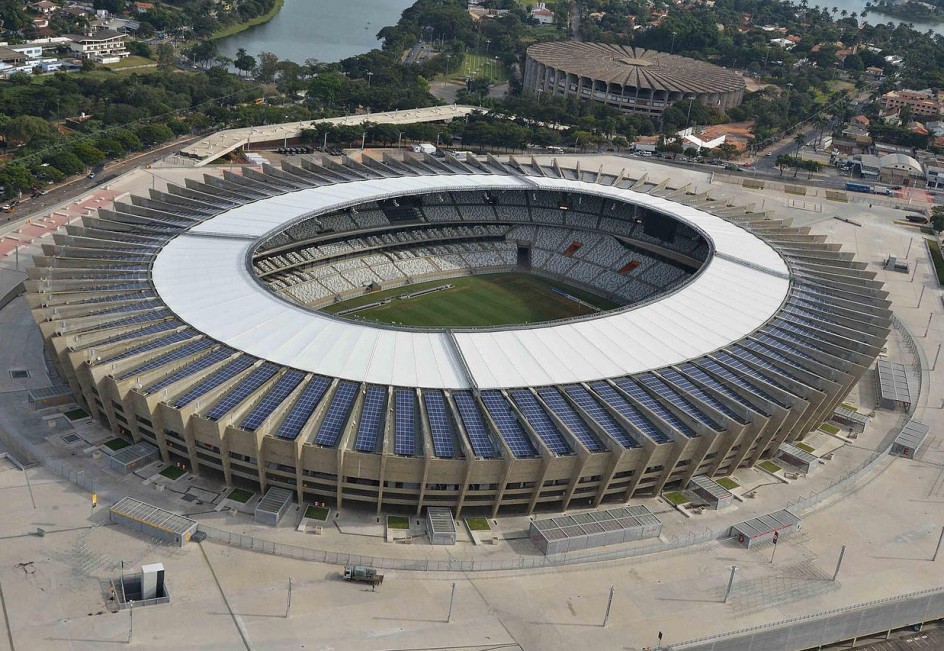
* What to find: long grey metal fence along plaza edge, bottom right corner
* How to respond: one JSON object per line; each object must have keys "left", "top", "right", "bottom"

{"left": 662, "top": 587, "right": 944, "bottom": 651}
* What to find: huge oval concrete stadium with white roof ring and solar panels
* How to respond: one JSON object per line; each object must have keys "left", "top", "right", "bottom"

{"left": 27, "top": 155, "right": 891, "bottom": 516}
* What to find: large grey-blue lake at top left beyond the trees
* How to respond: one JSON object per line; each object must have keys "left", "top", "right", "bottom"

{"left": 219, "top": 0, "right": 415, "bottom": 63}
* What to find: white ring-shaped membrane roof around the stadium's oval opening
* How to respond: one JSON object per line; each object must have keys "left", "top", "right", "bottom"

{"left": 152, "top": 175, "right": 789, "bottom": 389}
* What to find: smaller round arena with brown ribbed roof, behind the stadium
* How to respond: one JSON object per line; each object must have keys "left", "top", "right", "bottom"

{"left": 524, "top": 41, "right": 745, "bottom": 118}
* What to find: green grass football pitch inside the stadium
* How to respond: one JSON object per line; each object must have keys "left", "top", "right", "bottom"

{"left": 323, "top": 273, "right": 618, "bottom": 328}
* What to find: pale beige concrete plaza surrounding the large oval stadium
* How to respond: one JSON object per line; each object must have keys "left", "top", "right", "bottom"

{"left": 0, "top": 157, "right": 944, "bottom": 651}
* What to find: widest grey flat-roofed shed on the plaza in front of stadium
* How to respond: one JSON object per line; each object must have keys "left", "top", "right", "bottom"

{"left": 530, "top": 505, "right": 662, "bottom": 556}
